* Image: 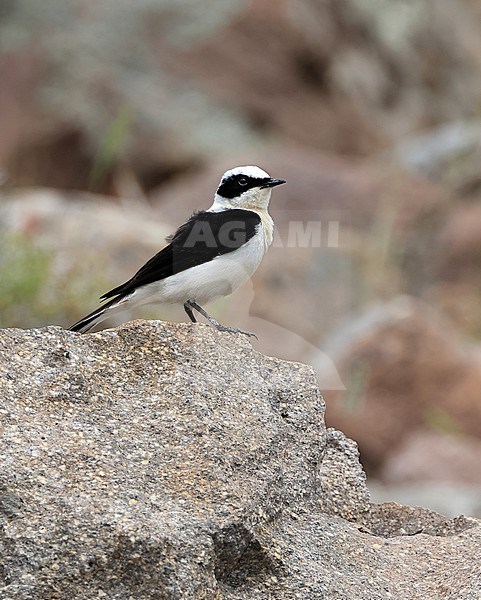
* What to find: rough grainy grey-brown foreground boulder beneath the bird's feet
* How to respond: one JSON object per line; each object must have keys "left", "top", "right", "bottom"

{"left": 0, "top": 321, "right": 481, "bottom": 600}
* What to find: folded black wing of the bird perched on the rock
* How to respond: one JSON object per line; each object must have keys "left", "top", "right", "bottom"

{"left": 101, "top": 209, "right": 261, "bottom": 299}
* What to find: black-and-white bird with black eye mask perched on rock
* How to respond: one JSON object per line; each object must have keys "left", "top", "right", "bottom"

{"left": 70, "top": 166, "right": 285, "bottom": 335}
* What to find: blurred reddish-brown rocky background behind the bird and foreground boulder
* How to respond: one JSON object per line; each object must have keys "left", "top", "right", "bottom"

{"left": 0, "top": 0, "right": 481, "bottom": 516}
